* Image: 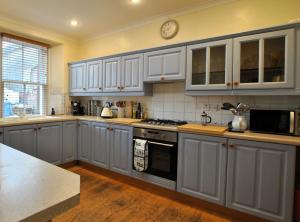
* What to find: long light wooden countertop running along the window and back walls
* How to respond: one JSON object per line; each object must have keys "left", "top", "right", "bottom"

{"left": 0, "top": 115, "right": 300, "bottom": 146}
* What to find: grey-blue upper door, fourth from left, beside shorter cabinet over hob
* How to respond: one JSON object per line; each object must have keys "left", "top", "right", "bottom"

{"left": 121, "top": 54, "right": 144, "bottom": 92}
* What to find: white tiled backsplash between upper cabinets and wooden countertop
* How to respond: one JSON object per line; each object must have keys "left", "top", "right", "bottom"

{"left": 77, "top": 82, "right": 300, "bottom": 125}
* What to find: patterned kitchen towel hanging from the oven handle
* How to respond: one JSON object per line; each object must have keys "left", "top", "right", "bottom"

{"left": 133, "top": 139, "right": 148, "bottom": 172}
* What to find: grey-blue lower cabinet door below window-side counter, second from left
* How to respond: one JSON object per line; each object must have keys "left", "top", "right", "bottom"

{"left": 37, "top": 122, "right": 62, "bottom": 165}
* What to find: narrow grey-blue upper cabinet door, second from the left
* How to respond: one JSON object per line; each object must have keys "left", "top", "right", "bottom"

{"left": 86, "top": 60, "right": 103, "bottom": 92}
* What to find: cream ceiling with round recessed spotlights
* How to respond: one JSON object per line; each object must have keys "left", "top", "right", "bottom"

{"left": 0, "top": 0, "right": 218, "bottom": 39}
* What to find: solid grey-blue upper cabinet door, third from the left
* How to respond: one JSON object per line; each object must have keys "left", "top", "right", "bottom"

{"left": 103, "top": 57, "right": 121, "bottom": 92}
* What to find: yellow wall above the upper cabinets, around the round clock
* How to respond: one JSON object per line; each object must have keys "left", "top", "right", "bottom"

{"left": 80, "top": 0, "right": 300, "bottom": 59}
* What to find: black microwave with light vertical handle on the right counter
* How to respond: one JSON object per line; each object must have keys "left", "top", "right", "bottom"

{"left": 250, "top": 109, "right": 300, "bottom": 136}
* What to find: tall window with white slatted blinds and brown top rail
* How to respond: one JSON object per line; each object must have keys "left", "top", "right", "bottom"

{"left": 1, "top": 34, "right": 48, "bottom": 117}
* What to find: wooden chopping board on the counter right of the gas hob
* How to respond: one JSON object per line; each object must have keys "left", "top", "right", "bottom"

{"left": 177, "top": 123, "right": 227, "bottom": 135}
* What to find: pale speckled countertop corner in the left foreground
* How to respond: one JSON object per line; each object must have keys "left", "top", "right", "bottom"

{"left": 0, "top": 144, "right": 80, "bottom": 222}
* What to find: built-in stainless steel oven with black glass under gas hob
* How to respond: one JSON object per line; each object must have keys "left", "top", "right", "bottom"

{"left": 133, "top": 128, "right": 178, "bottom": 181}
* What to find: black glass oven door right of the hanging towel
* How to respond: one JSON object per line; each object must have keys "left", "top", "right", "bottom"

{"left": 146, "top": 140, "right": 177, "bottom": 181}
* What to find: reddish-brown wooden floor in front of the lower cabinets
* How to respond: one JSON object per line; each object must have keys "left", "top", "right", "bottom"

{"left": 53, "top": 166, "right": 244, "bottom": 222}
